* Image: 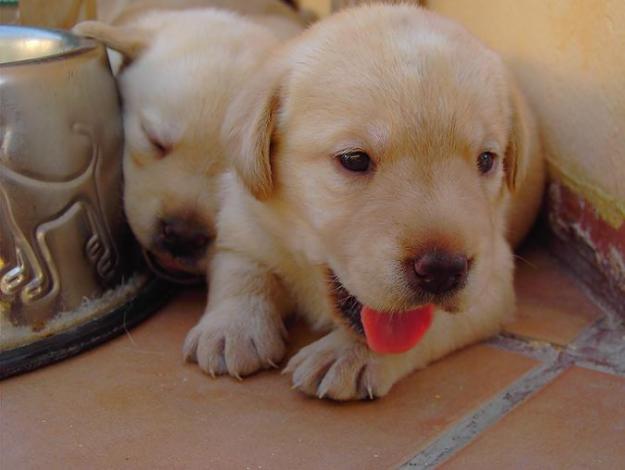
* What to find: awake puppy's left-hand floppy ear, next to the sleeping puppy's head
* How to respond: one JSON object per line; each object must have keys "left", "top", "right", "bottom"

{"left": 222, "top": 60, "right": 287, "bottom": 200}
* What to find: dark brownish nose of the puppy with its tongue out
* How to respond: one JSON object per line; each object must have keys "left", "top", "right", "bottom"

{"left": 414, "top": 250, "right": 469, "bottom": 294}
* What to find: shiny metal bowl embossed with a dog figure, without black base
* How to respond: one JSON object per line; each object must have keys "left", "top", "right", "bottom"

{"left": 0, "top": 26, "right": 169, "bottom": 375}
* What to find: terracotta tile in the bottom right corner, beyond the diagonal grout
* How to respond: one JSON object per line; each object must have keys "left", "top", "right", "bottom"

{"left": 443, "top": 367, "right": 625, "bottom": 470}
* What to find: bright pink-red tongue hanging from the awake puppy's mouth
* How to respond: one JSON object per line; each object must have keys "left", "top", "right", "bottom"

{"left": 360, "top": 304, "right": 434, "bottom": 354}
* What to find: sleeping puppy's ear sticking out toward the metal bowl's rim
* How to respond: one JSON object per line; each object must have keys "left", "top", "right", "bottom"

{"left": 72, "top": 21, "right": 151, "bottom": 63}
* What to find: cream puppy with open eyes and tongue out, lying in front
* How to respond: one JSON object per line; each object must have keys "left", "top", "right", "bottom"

{"left": 184, "top": 5, "right": 543, "bottom": 400}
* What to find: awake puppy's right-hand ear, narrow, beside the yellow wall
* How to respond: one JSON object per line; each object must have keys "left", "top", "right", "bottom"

{"left": 503, "top": 79, "right": 538, "bottom": 191}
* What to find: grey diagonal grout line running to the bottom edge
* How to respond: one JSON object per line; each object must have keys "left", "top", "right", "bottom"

{"left": 400, "top": 353, "right": 572, "bottom": 470}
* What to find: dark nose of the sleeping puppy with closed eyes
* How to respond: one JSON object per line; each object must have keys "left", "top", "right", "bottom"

{"left": 156, "top": 219, "right": 211, "bottom": 258}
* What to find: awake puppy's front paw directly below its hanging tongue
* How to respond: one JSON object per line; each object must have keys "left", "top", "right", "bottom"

{"left": 283, "top": 330, "right": 395, "bottom": 400}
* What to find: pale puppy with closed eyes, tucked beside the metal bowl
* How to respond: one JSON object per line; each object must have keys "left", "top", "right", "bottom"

{"left": 75, "top": 0, "right": 303, "bottom": 281}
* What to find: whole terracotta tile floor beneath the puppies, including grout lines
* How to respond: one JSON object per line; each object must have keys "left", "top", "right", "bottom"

{"left": 0, "top": 246, "right": 625, "bottom": 469}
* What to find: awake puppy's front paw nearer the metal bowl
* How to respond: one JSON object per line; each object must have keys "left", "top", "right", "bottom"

{"left": 183, "top": 308, "right": 286, "bottom": 379}
